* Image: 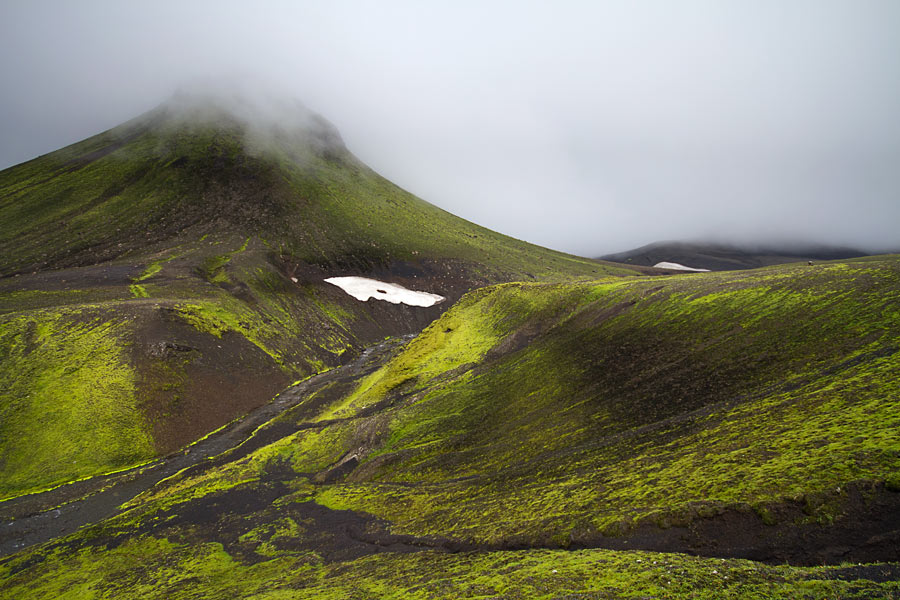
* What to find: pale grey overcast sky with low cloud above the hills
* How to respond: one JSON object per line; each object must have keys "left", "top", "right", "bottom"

{"left": 0, "top": 0, "right": 900, "bottom": 256}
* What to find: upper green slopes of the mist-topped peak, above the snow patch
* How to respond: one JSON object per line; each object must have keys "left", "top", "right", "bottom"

{"left": 0, "top": 104, "right": 634, "bottom": 280}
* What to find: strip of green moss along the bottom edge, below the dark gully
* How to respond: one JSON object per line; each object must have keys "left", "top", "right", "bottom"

{"left": 0, "top": 536, "right": 900, "bottom": 600}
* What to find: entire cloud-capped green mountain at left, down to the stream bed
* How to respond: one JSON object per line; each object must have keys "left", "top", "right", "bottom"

{"left": 0, "top": 97, "right": 635, "bottom": 500}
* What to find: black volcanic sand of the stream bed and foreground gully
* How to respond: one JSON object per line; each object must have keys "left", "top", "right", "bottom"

{"left": 0, "top": 337, "right": 900, "bottom": 580}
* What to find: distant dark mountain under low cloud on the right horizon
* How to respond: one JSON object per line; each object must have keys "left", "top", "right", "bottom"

{"left": 601, "top": 242, "right": 868, "bottom": 271}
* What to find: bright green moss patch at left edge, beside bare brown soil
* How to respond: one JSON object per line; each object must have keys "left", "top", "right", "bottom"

{"left": 0, "top": 309, "right": 153, "bottom": 499}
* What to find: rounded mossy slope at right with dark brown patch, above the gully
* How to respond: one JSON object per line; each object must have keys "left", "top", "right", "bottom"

{"left": 310, "top": 259, "right": 900, "bottom": 543}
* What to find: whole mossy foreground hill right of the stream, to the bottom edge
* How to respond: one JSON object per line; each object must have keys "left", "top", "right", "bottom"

{"left": 0, "top": 256, "right": 900, "bottom": 598}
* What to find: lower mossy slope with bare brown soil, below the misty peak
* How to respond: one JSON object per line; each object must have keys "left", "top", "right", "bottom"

{"left": 0, "top": 238, "right": 384, "bottom": 499}
